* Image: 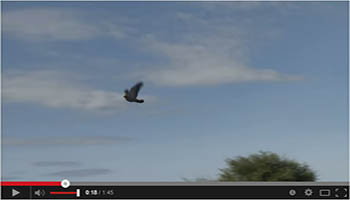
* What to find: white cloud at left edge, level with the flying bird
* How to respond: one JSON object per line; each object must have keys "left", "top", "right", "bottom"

{"left": 3, "top": 70, "right": 126, "bottom": 112}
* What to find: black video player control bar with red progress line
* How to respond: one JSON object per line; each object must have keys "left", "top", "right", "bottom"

{"left": 2, "top": 182, "right": 349, "bottom": 199}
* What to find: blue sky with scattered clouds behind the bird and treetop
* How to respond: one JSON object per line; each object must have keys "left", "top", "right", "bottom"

{"left": 1, "top": 2, "right": 349, "bottom": 181}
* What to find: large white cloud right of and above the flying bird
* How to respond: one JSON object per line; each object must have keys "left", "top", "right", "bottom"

{"left": 137, "top": 34, "right": 301, "bottom": 86}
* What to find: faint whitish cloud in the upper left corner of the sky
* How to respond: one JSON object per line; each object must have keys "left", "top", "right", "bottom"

{"left": 2, "top": 8, "right": 128, "bottom": 40}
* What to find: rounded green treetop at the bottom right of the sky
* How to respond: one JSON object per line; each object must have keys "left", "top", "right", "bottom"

{"left": 219, "top": 151, "right": 317, "bottom": 181}
